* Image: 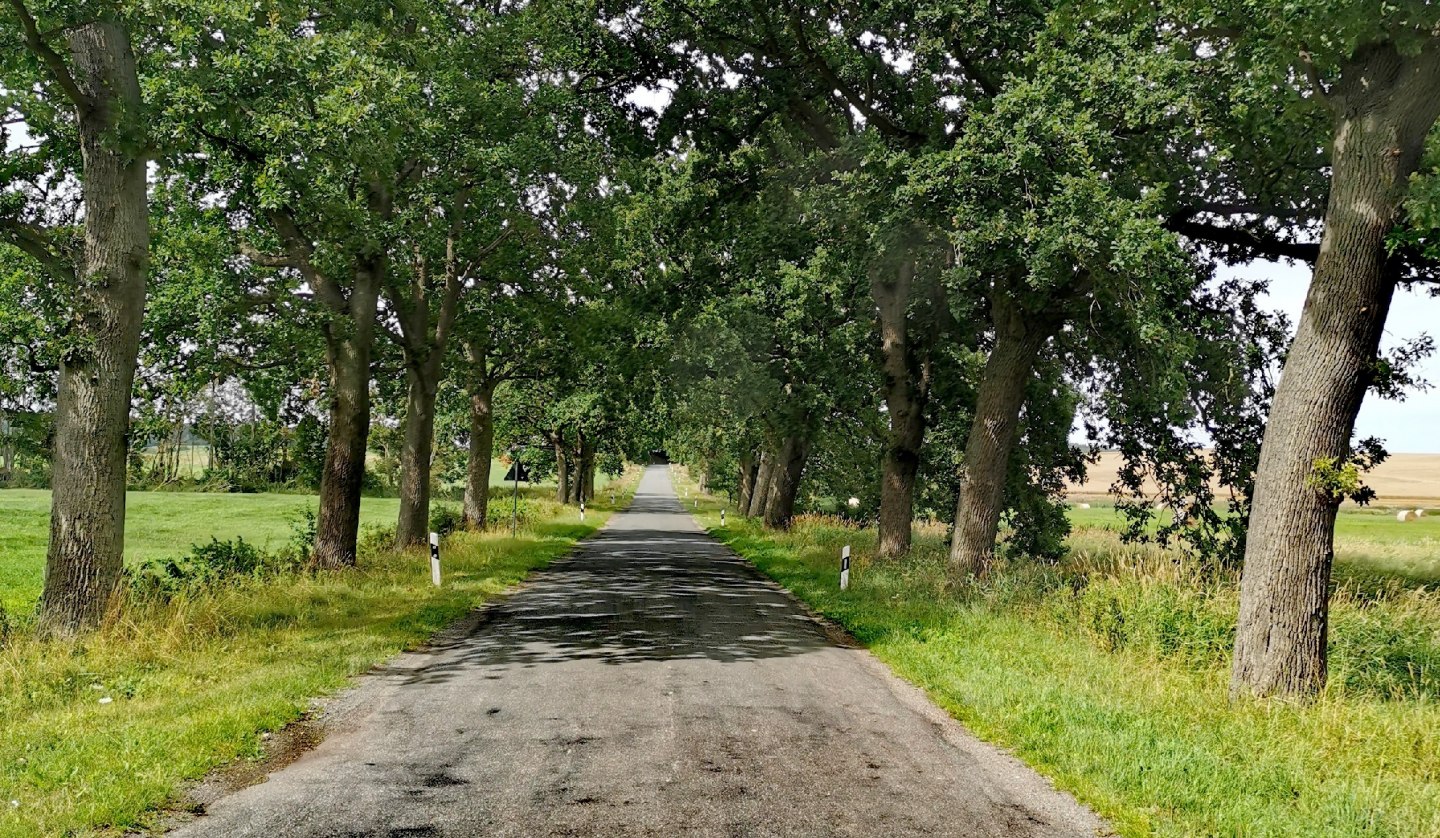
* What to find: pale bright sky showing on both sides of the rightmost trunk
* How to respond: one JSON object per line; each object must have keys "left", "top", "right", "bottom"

{"left": 1234, "top": 262, "right": 1440, "bottom": 454}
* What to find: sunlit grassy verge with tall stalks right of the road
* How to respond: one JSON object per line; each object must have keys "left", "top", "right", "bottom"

{"left": 673, "top": 472, "right": 1440, "bottom": 838}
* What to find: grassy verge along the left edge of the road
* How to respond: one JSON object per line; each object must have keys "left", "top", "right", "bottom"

{"left": 0, "top": 472, "right": 634, "bottom": 838}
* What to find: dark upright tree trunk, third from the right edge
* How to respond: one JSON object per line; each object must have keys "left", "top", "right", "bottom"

{"left": 870, "top": 256, "right": 930, "bottom": 559}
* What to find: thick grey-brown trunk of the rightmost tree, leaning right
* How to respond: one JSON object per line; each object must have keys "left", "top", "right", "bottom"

{"left": 1230, "top": 43, "right": 1440, "bottom": 695}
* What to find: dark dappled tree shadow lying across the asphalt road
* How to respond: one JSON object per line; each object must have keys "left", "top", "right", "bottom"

{"left": 394, "top": 515, "right": 829, "bottom": 684}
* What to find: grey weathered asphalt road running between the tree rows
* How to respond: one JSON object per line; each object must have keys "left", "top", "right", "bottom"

{"left": 173, "top": 467, "right": 1104, "bottom": 838}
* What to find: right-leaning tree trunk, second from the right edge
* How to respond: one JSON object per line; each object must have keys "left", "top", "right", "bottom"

{"left": 950, "top": 299, "right": 1058, "bottom": 576}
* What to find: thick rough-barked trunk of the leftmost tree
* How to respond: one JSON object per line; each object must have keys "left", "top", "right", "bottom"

{"left": 40, "top": 22, "right": 150, "bottom": 634}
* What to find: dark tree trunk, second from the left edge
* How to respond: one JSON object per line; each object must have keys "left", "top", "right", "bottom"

{"left": 312, "top": 256, "right": 386, "bottom": 567}
